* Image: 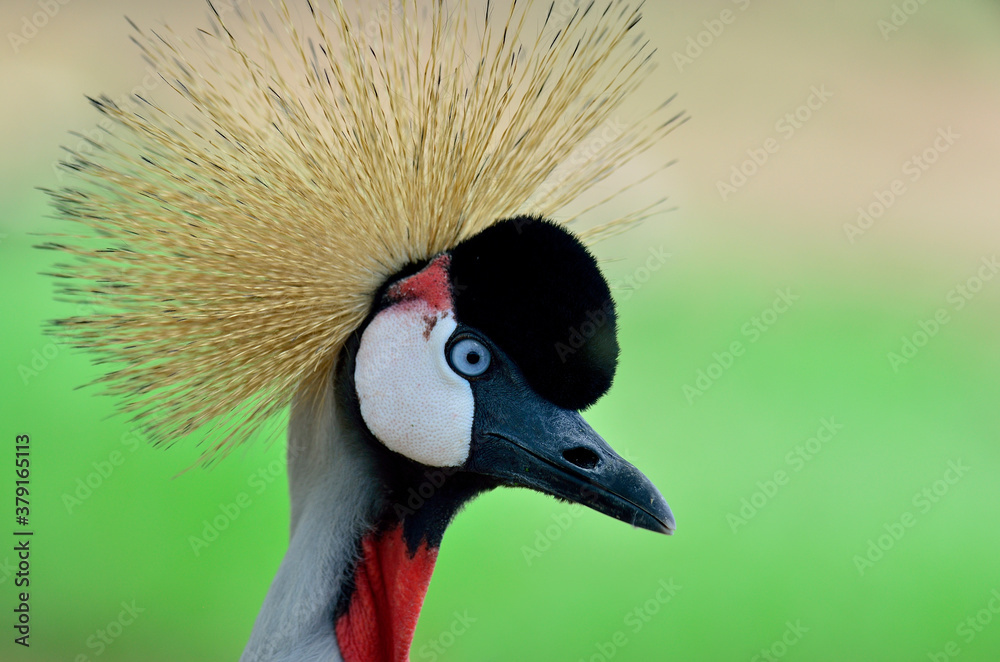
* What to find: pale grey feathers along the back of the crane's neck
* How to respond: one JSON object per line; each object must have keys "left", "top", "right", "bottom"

{"left": 240, "top": 378, "right": 380, "bottom": 662}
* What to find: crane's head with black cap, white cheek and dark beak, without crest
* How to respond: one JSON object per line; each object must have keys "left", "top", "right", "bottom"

{"left": 353, "top": 216, "right": 674, "bottom": 534}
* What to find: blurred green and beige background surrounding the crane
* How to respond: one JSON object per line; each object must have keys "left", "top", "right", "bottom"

{"left": 0, "top": 0, "right": 1000, "bottom": 662}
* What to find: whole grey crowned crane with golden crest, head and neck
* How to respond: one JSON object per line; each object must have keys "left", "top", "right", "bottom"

{"left": 45, "top": 0, "right": 683, "bottom": 662}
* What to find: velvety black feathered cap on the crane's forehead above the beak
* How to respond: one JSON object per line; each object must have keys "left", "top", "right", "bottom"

{"left": 449, "top": 216, "right": 618, "bottom": 409}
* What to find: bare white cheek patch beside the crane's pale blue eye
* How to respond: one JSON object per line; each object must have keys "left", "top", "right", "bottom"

{"left": 354, "top": 300, "right": 474, "bottom": 467}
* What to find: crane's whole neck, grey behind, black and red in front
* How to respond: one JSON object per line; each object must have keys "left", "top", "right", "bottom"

{"left": 241, "top": 368, "right": 488, "bottom": 662}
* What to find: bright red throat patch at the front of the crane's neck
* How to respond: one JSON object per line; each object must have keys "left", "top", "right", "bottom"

{"left": 335, "top": 525, "right": 438, "bottom": 662}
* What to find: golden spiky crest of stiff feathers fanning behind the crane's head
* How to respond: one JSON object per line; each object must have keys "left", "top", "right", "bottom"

{"left": 45, "top": 0, "right": 684, "bottom": 460}
